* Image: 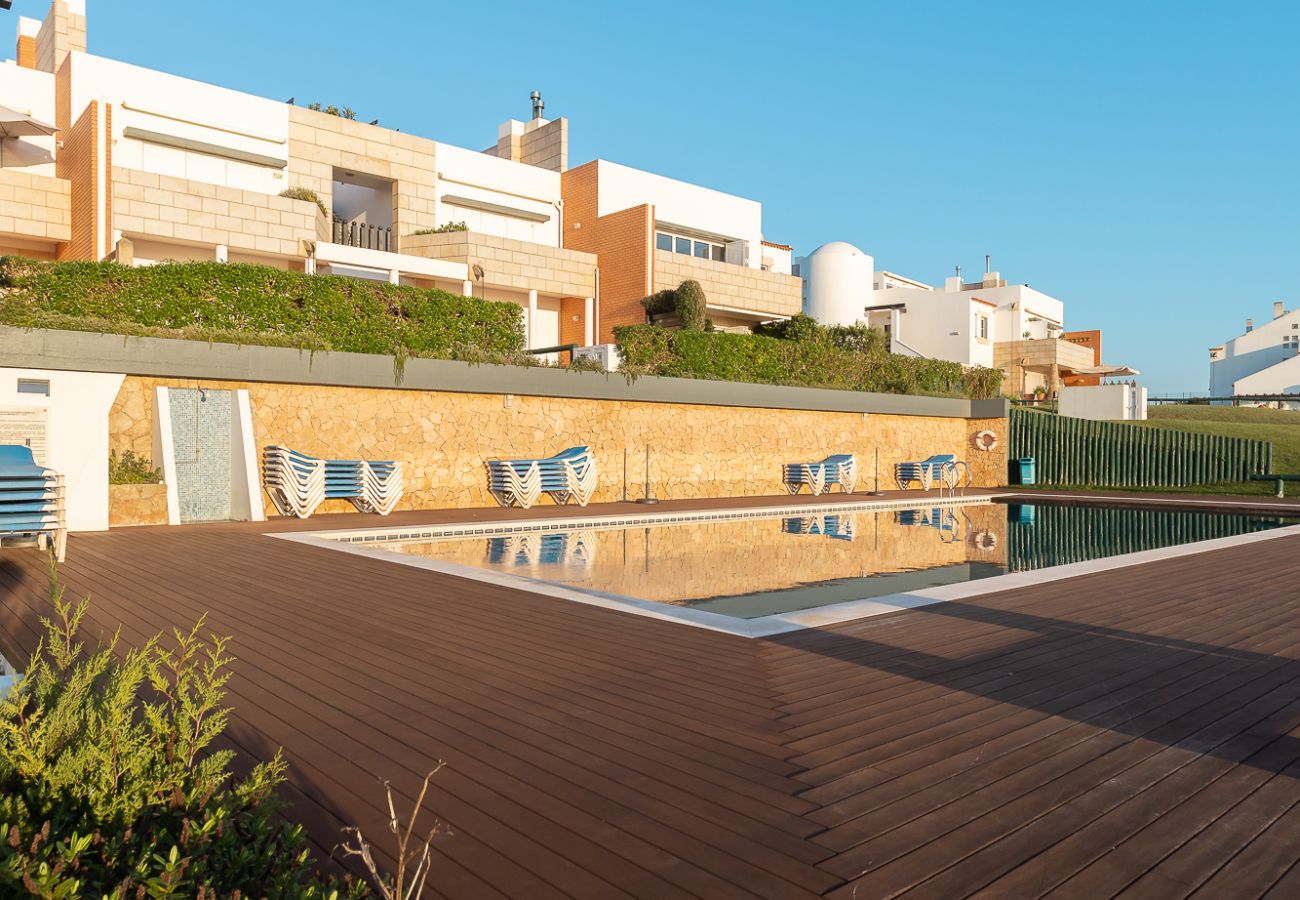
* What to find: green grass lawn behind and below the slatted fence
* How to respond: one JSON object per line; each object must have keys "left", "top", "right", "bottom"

{"left": 1013, "top": 404, "right": 1300, "bottom": 497}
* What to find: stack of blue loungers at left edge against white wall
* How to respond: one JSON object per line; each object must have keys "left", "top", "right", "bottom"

{"left": 0, "top": 443, "right": 68, "bottom": 562}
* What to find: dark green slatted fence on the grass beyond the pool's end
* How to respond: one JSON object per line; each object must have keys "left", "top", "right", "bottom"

{"left": 1009, "top": 408, "right": 1273, "bottom": 488}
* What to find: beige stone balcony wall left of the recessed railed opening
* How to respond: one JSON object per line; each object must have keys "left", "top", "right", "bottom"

{"left": 113, "top": 166, "right": 320, "bottom": 256}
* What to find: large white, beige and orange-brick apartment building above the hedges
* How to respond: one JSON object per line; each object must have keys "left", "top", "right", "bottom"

{"left": 0, "top": 0, "right": 800, "bottom": 349}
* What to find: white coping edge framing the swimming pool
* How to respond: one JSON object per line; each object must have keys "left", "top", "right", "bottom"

{"left": 267, "top": 492, "right": 1300, "bottom": 637}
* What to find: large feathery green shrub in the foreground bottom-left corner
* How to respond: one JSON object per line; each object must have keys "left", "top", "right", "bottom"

{"left": 0, "top": 567, "right": 367, "bottom": 897}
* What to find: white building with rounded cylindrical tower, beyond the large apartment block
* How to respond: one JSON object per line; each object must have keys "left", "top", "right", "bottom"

{"left": 798, "top": 242, "right": 1138, "bottom": 397}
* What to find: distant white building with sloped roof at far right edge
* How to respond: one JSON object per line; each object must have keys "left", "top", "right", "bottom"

{"left": 1210, "top": 300, "right": 1300, "bottom": 398}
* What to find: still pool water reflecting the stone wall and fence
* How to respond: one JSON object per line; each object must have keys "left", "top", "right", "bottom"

{"left": 373, "top": 503, "right": 1300, "bottom": 619}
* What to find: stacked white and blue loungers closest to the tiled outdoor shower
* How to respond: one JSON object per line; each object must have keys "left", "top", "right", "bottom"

{"left": 261, "top": 446, "right": 403, "bottom": 519}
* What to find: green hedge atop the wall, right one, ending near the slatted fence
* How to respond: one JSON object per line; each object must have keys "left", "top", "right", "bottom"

{"left": 614, "top": 319, "right": 1002, "bottom": 399}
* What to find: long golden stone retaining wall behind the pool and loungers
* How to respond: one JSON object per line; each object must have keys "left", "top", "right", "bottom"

{"left": 109, "top": 376, "right": 1006, "bottom": 511}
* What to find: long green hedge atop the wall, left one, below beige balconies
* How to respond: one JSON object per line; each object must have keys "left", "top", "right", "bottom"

{"left": 0, "top": 256, "right": 524, "bottom": 359}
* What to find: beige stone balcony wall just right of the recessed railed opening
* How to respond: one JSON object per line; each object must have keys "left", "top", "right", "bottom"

{"left": 402, "top": 232, "right": 595, "bottom": 298}
